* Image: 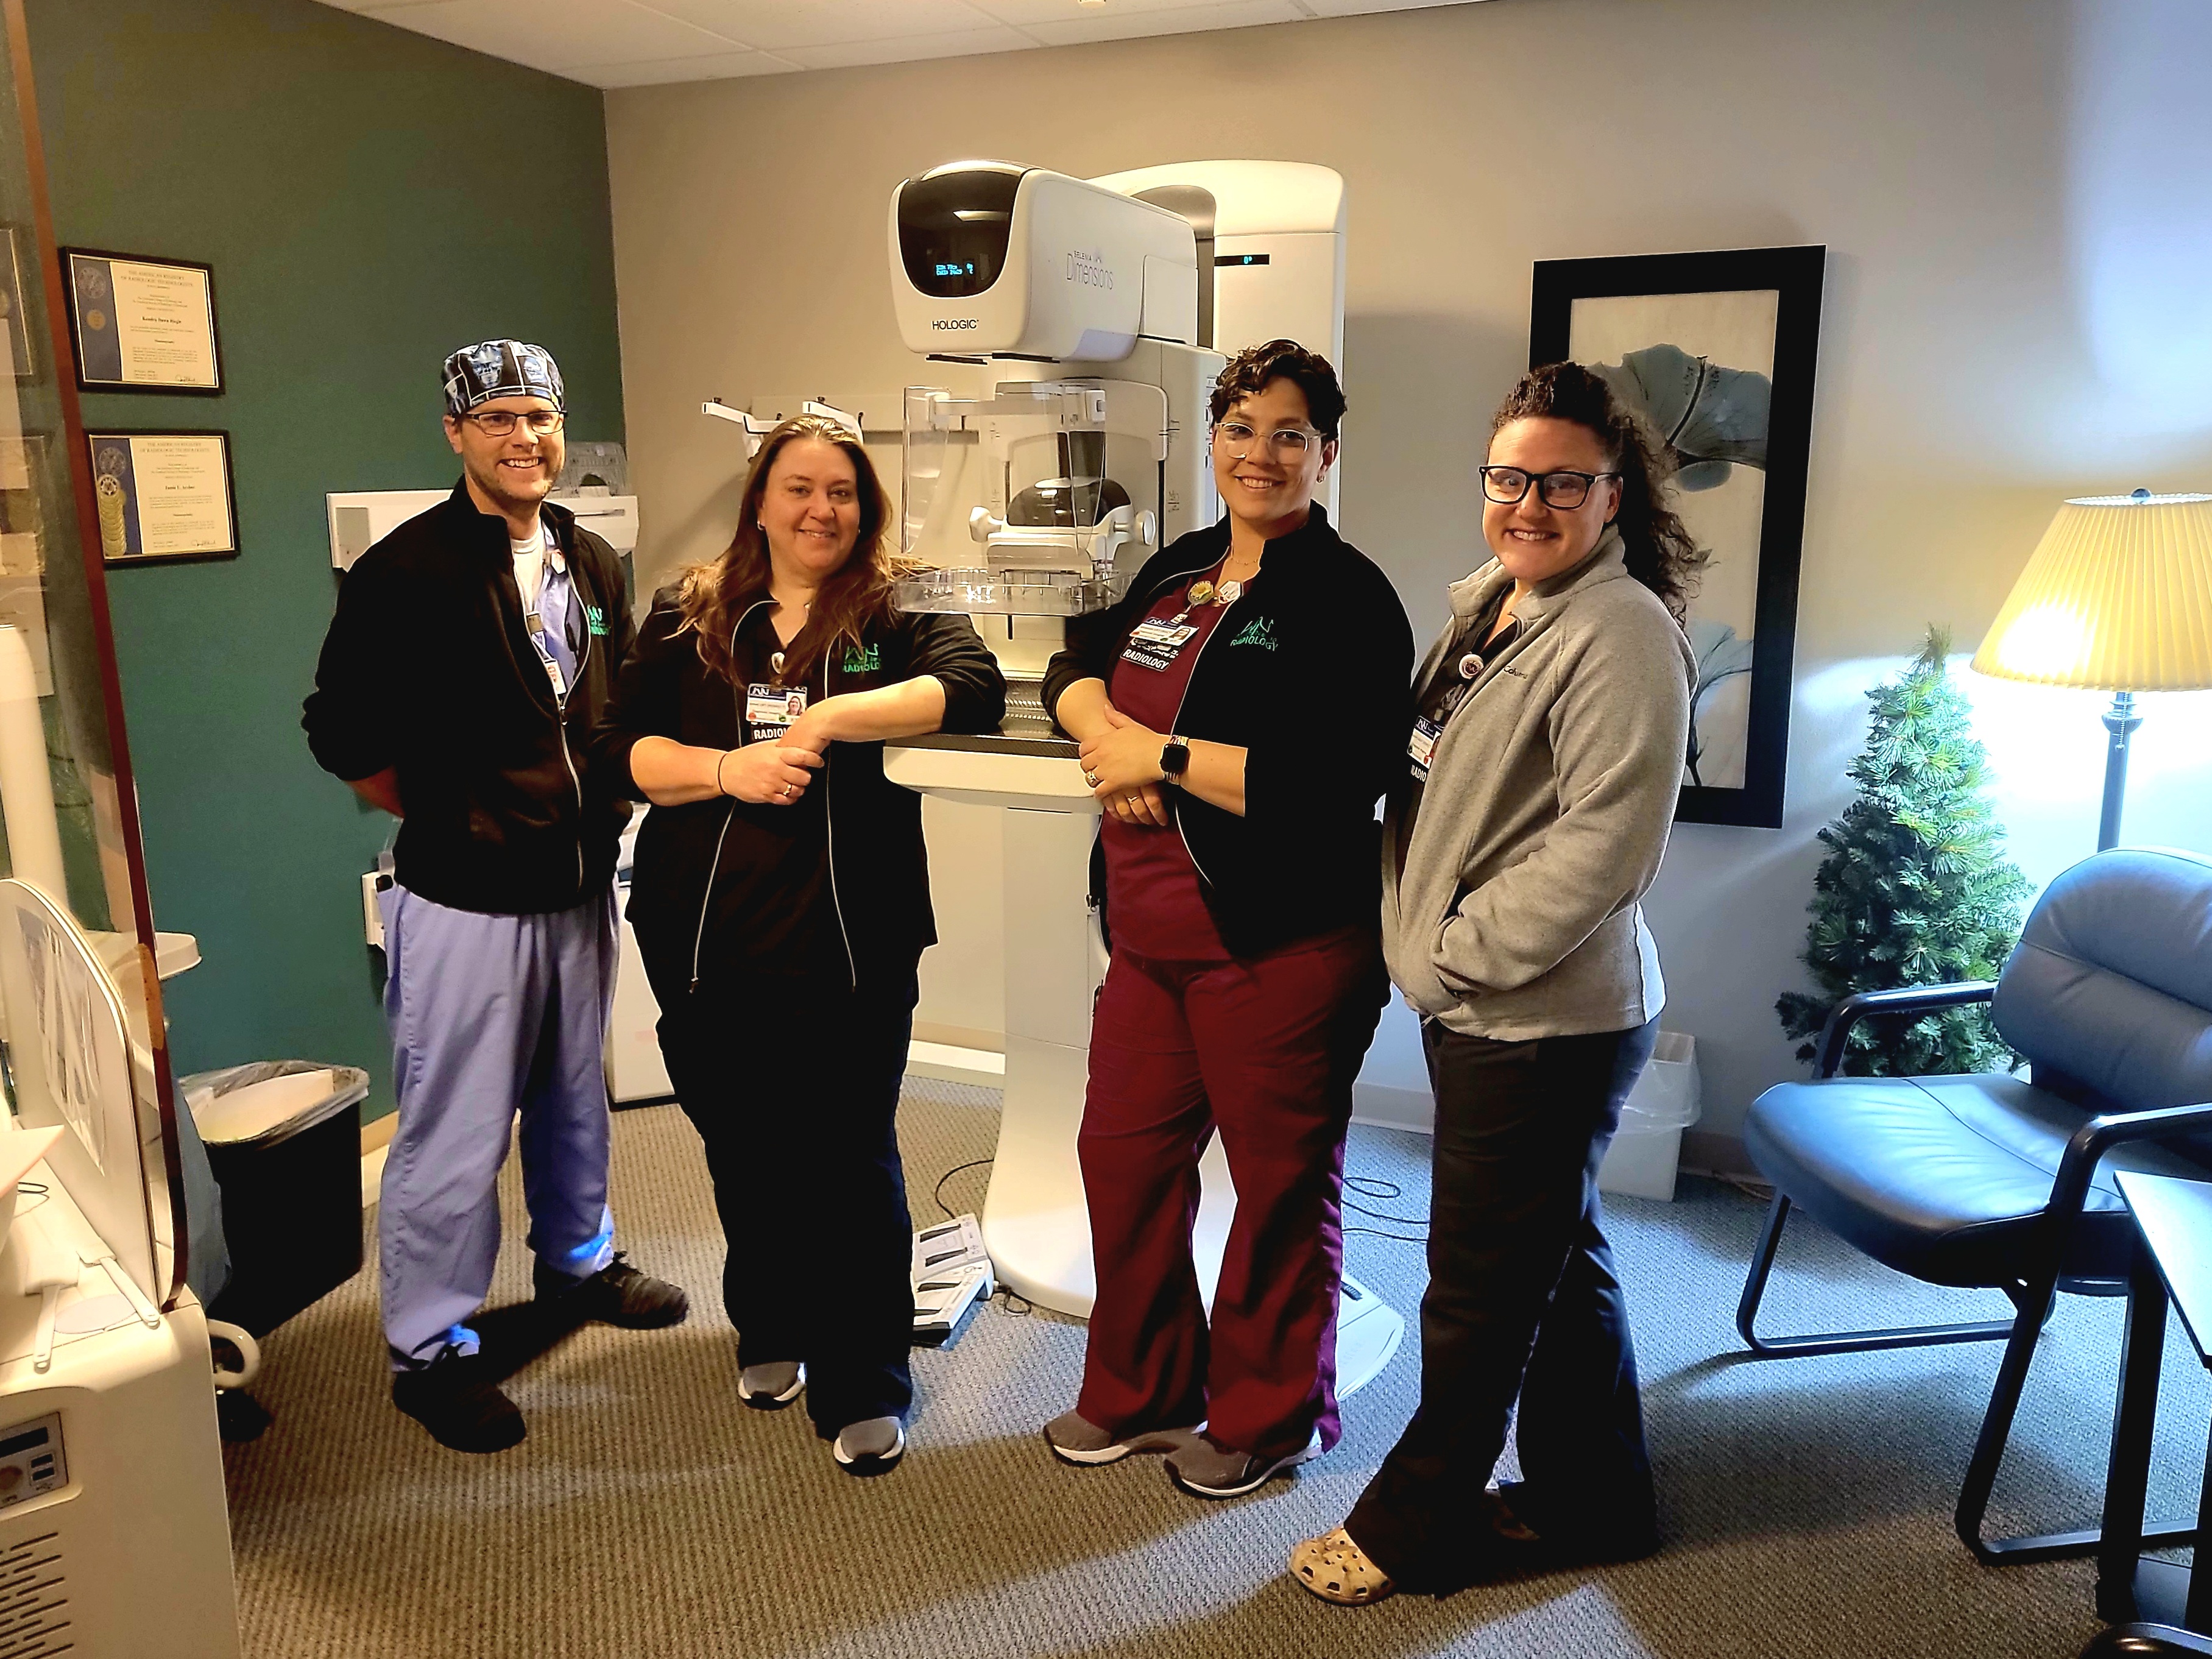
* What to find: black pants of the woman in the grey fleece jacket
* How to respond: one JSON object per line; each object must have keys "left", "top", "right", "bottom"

{"left": 1345, "top": 1020, "right": 1659, "bottom": 1593}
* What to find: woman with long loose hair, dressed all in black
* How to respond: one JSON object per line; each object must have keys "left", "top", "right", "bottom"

{"left": 595, "top": 416, "right": 1006, "bottom": 1476}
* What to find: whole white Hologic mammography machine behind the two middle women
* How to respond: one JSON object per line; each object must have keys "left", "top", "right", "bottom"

{"left": 885, "top": 161, "right": 1405, "bottom": 1393}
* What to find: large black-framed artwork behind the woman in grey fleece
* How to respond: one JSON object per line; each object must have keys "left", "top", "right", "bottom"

{"left": 1528, "top": 248, "right": 1827, "bottom": 830}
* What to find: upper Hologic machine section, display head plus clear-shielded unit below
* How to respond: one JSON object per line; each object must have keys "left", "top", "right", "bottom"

{"left": 889, "top": 161, "right": 1221, "bottom": 617}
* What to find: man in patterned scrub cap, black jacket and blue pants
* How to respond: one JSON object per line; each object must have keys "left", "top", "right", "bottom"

{"left": 303, "top": 341, "right": 690, "bottom": 1451}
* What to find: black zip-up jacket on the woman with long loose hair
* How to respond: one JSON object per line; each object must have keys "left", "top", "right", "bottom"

{"left": 590, "top": 589, "right": 1006, "bottom": 1002}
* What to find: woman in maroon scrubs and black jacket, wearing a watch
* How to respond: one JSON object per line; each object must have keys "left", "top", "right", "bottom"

{"left": 1044, "top": 341, "right": 1413, "bottom": 1498}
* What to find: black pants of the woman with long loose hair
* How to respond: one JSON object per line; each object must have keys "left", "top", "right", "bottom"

{"left": 659, "top": 975, "right": 916, "bottom": 1440}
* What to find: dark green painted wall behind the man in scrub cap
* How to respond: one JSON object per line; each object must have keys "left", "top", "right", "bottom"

{"left": 29, "top": 0, "right": 621, "bottom": 1115}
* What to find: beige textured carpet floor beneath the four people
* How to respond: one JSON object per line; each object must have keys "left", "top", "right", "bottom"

{"left": 228, "top": 1080, "right": 2205, "bottom": 1659}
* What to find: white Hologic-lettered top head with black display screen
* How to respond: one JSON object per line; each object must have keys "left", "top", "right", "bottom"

{"left": 891, "top": 161, "right": 1199, "bottom": 363}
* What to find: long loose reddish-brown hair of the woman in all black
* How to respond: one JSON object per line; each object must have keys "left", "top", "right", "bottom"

{"left": 677, "top": 414, "right": 898, "bottom": 686}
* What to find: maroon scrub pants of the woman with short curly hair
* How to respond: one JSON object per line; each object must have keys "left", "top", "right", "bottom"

{"left": 1075, "top": 927, "right": 1389, "bottom": 1458}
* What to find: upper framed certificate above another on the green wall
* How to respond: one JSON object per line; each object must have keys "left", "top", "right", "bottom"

{"left": 62, "top": 248, "right": 224, "bottom": 396}
